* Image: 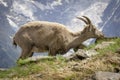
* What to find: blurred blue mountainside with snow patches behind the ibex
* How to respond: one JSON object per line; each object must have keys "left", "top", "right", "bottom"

{"left": 0, "top": 0, "right": 120, "bottom": 68}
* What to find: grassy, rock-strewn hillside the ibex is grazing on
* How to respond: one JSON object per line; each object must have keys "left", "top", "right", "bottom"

{"left": 0, "top": 38, "right": 120, "bottom": 80}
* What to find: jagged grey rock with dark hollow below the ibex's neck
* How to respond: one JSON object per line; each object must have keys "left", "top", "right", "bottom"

{"left": 66, "top": 49, "right": 98, "bottom": 60}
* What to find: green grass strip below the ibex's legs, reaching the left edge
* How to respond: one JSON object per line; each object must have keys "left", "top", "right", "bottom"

{"left": 0, "top": 55, "right": 65, "bottom": 78}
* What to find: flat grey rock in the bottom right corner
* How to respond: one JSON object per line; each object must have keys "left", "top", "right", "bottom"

{"left": 92, "top": 71, "right": 120, "bottom": 80}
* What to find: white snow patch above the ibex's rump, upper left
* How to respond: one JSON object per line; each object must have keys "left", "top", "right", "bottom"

{"left": 12, "top": 1, "right": 36, "bottom": 20}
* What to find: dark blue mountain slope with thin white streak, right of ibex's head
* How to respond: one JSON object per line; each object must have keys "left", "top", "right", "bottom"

{"left": 102, "top": 0, "right": 120, "bottom": 37}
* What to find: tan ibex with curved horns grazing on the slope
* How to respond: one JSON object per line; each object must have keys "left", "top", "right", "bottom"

{"left": 13, "top": 16, "right": 103, "bottom": 59}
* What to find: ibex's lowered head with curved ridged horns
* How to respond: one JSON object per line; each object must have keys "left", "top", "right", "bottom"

{"left": 77, "top": 16, "right": 104, "bottom": 38}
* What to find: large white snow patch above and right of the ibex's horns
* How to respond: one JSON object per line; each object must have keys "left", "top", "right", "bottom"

{"left": 77, "top": 2, "right": 108, "bottom": 27}
